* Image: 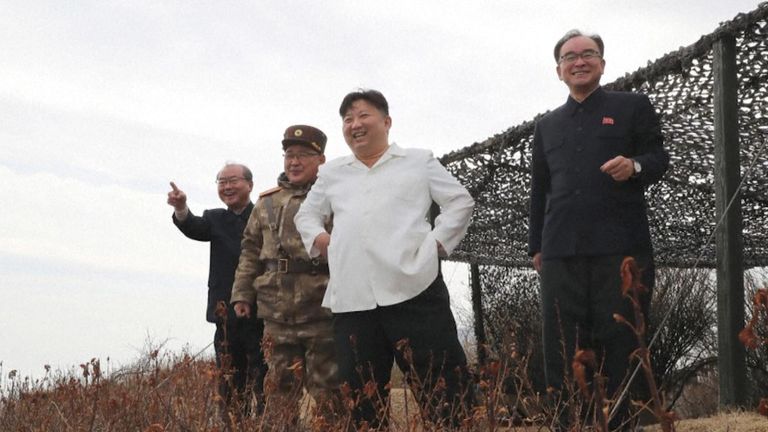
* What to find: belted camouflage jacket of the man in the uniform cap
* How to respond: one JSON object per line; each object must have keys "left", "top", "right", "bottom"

{"left": 230, "top": 174, "right": 332, "bottom": 324}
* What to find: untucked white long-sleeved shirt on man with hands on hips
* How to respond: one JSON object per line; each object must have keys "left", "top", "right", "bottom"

{"left": 294, "top": 143, "right": 474, "bottom": 313}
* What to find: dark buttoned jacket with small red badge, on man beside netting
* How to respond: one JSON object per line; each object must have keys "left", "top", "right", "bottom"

{"left": 528, "top": 88, "right": 669, "bottom": 259}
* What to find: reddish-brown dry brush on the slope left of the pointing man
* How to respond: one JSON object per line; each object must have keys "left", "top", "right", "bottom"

{"left": 0, "top": 350, "right": 224, "bottom": 431}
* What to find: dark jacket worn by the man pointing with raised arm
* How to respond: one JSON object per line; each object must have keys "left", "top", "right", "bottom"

{"left": 173, "top": 203, "right": 256, "bottom": 322}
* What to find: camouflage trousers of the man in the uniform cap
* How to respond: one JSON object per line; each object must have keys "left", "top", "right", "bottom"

{"left": 262, "top": 319, "right": 339, "bottom": 421}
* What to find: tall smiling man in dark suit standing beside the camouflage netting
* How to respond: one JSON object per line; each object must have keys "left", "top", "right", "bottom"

{"left": 528, "top": 30, "right": 669, "bottom": 430}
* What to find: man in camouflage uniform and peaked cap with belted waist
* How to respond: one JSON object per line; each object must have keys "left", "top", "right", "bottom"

{"left": 231, "top": 125, "right": 338, "bottom": 423}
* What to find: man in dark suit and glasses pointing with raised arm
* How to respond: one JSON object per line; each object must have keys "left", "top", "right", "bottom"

{"left": 168, "top": 164, "right": 267, "bottom": 419}
